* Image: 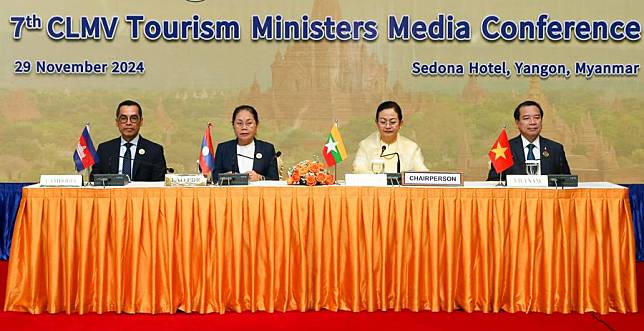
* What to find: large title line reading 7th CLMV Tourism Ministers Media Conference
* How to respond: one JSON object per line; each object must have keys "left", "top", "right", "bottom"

{"left": 9, "top": 13, "right": 642, "bottom": 42}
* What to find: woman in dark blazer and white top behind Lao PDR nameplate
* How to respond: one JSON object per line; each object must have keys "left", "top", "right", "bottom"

{"left": 213, "top": 105, "right": 279, "bottom": 181}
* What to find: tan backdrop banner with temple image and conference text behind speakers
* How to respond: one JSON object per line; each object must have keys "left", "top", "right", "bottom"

{"left": 0, "top": 0, "right": 644, "bottom": 183}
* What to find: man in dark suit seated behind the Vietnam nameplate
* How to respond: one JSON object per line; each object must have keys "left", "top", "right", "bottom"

{"left": 487, "top": 100, "right": 570, "bottom": 180}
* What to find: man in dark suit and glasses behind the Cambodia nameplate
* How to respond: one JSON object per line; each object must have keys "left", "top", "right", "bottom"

{"left": 90, "top": 100, "right": 166, "bottom": 182}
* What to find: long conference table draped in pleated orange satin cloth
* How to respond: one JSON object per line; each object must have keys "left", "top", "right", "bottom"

{"left": 4, "top": 182, "right": 637, "bottom": 314}
